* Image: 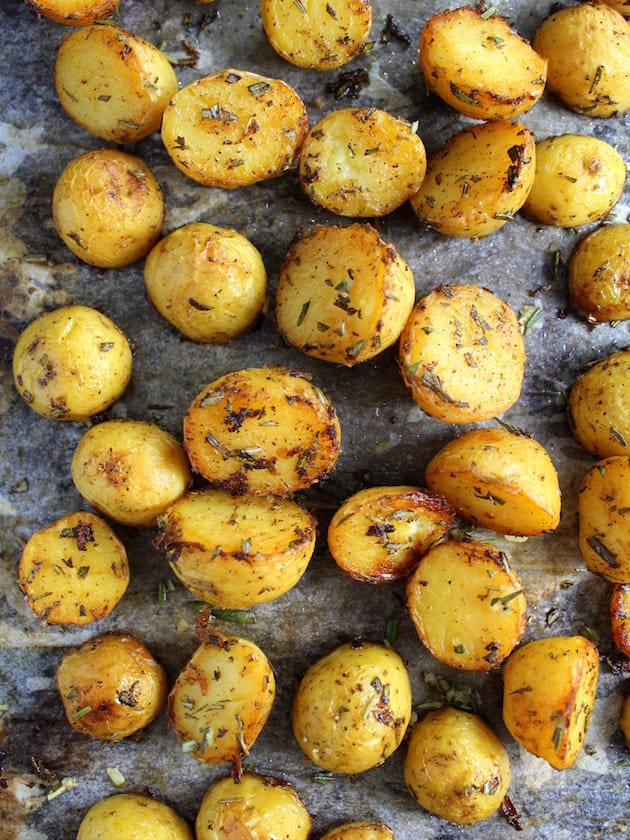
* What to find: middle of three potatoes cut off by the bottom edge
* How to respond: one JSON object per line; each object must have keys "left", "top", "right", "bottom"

{"left": 195, "top": 772, "right": 311, "bottom": 840}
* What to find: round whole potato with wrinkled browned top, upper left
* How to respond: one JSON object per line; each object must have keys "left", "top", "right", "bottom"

{"left": 52, "top": 149, "right": 164, "bottom": 268}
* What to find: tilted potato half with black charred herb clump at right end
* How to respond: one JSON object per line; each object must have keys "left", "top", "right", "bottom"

{"left": 410, "top": 120, "right": 536, "bottom": 239}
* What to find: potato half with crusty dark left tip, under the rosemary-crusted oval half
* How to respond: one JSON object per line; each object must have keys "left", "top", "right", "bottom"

{"left": 156, "top": 488, "right": 317, "bottom": 609}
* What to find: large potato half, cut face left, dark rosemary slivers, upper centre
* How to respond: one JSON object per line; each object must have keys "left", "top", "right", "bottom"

{"left": 276, "top": 223, "right": 415, "bottom": 367}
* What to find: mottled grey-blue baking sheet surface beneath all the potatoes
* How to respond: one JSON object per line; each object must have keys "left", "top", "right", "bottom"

{"left": 0, "top": 0, "right": 630, "bottom": 840}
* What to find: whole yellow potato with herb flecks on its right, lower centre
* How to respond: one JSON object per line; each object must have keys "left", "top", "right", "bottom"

{"left": 291, "top": 640, "right": 411, "bottom": 774}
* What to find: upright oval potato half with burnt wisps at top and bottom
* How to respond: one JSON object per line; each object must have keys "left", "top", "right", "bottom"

{"left": 168, "top": 631, "right": 276, "bottom": 767}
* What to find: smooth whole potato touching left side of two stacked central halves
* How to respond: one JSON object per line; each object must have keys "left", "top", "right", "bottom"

{"left": 71, "top": 419, "right": 192, "bottom": 525}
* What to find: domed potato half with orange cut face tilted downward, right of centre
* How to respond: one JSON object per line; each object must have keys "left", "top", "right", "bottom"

{"left": 426, "top": 428, "right": 560, "bottom": 537}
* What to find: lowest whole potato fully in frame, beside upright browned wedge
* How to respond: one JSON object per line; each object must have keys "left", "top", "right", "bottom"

{"left": 404, "top": 706, "right": 511, "bottom": 825}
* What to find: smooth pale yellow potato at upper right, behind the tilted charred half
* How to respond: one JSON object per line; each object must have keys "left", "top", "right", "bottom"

{"left": 523, "top": 134, "right": 626, "bottom": 227}
